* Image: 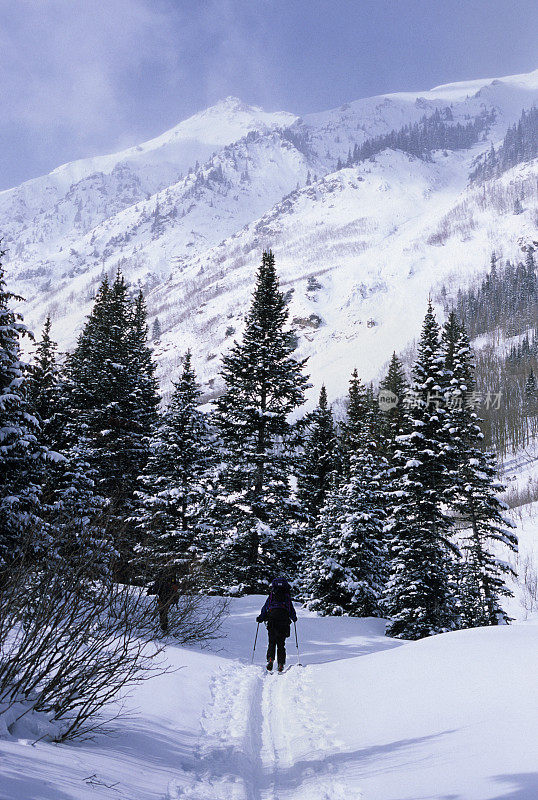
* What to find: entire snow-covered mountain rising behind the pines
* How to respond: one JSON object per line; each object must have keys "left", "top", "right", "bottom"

{"left": 4, "top": 70, "right": 538, "bottom": 398}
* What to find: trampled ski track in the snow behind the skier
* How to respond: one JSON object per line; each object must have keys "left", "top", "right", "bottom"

{"left": 166, "top": 662, "right": 356, "bottom": 800}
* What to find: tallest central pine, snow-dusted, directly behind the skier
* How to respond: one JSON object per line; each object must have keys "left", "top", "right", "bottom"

{"left": 210, "top": 251, "right": 308, "bottom": 592}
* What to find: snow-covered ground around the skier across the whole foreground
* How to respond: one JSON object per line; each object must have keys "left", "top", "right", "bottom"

{"left": 0, "top": 564, "right": 538, "bottom": 800}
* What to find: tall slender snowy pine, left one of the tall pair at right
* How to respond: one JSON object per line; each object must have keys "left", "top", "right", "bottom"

{"left": 385, "top": 303, "right": 457, "bottom": 639}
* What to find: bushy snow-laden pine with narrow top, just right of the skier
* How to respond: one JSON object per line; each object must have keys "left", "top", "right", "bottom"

{"left": 304, "top": 371, "right": 386, "bottom": 616}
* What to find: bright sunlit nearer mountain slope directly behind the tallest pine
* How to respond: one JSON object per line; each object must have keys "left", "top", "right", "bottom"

{"left": 150, "top": 152, "right": 538, "bottom": 399}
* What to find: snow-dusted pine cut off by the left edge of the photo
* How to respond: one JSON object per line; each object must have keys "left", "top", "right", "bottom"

{"left": 0, "top": 251, "right": 46, "bottom": 568}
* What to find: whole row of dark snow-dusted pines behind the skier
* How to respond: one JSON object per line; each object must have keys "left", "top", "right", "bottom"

{"left": 0, "top": 252, "right": 516, "bottom": 638}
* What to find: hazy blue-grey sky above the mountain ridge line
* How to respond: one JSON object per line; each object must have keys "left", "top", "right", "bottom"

{"left": 0, "top": 0, "right": 538, "bottom": 189}
